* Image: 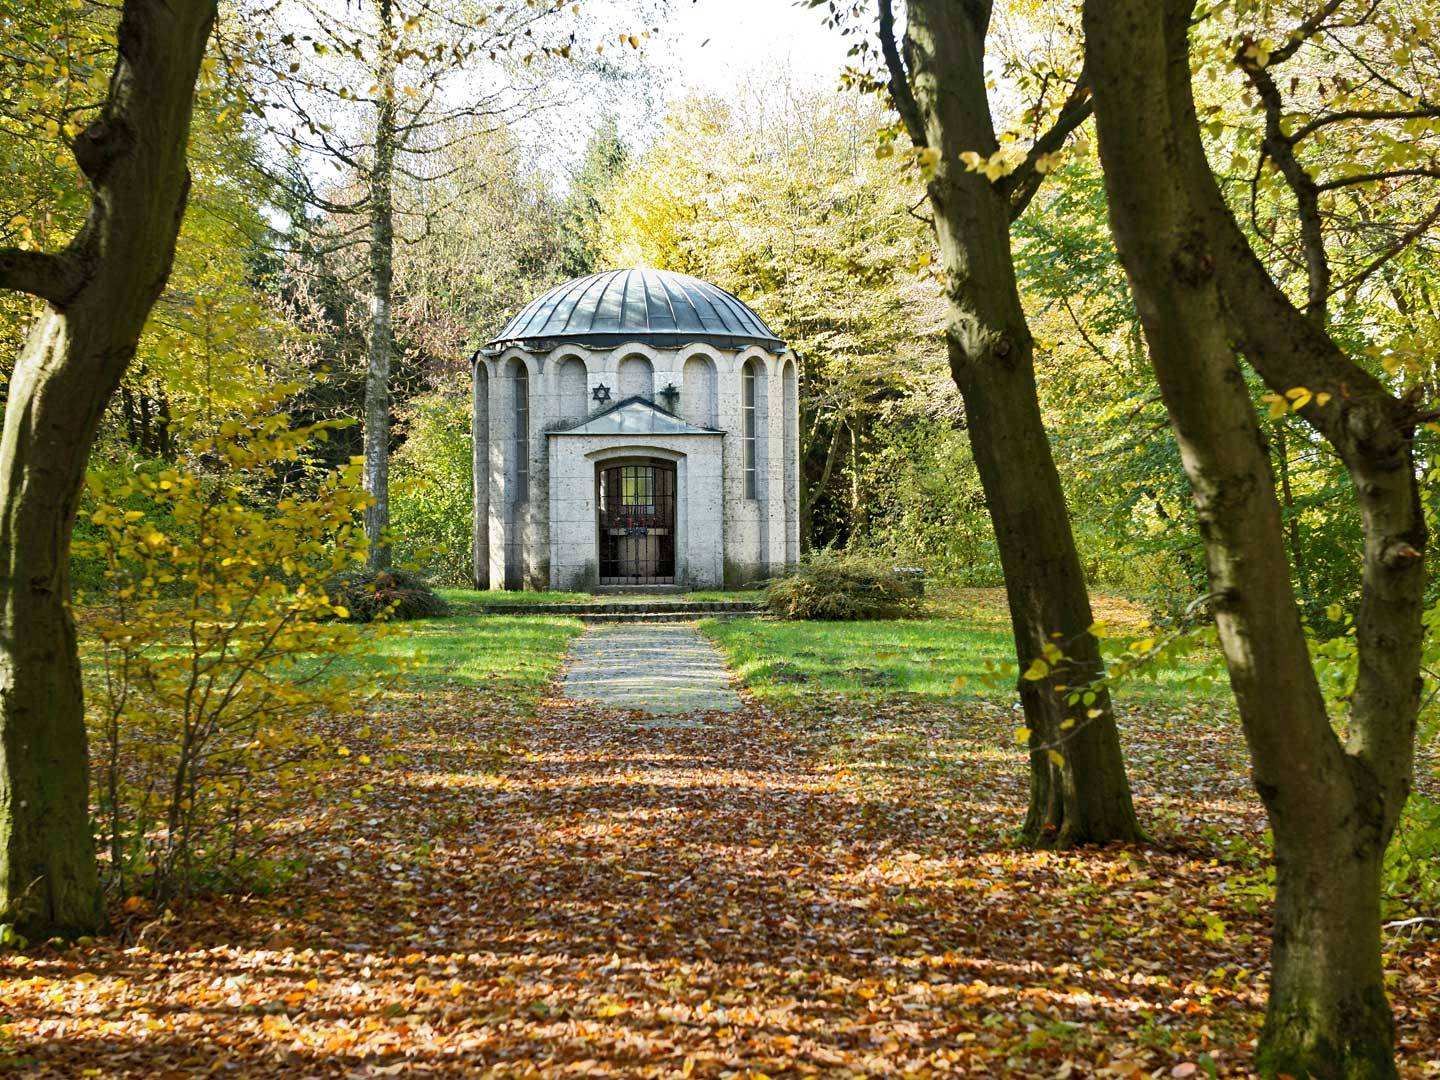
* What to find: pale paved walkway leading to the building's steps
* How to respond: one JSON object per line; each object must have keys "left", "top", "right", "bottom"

{"left": 563, "top": 622, "right": 740, "bottom": 716}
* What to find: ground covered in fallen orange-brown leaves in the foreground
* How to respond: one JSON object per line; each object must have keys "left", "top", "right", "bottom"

{"left": 0, "top": 616, "right": 1440, "bottom": 1080}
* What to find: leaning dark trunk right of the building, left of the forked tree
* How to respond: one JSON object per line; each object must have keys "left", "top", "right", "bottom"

{"left": 906, "top": 0, "right": 1142, "bottom": 847}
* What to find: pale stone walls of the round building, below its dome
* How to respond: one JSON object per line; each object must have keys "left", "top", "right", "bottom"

{"left": 474, "top": 340, "right": 799, "bottom": 590}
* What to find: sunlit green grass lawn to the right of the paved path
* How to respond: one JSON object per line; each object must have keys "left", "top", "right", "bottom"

{"left": 701, "top": 589, "right": 1207, "bottom": 706}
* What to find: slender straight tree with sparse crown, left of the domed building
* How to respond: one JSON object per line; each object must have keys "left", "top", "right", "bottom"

{"left": 253, "top": 0, "right": 648, "bottom": 570}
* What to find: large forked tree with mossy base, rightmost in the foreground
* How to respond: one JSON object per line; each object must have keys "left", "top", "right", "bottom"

{"left": 1084, "top": 0, "right": 1440, "bottom": 1080}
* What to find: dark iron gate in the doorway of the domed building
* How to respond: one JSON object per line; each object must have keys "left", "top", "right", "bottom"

{"left": 599, "top": 461, "right": 675, "bottom": 585}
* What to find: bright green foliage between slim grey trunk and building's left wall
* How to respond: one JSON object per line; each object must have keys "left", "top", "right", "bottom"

{"left": 390, "top": 392, "right": 472, "bottom": 585}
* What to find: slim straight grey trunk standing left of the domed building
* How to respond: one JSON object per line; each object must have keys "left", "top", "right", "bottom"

{"left": 364, "top": 0, "right": 396, "bottom": 570}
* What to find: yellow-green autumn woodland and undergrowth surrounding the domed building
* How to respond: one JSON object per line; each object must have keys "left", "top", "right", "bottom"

{"left": 0, "top": 0, "right": 1440, "bottom": 1077}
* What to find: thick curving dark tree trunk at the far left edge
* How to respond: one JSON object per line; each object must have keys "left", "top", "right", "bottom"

{"left": 0, "top": 0, "right": 215, "bottom": 939}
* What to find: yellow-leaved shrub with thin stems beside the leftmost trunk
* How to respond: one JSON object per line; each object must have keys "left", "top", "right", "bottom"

{"left": 82, "top": 386, "right": 383, "bottom": 897}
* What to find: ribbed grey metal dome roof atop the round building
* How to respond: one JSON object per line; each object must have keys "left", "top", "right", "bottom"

{"left": 488, "top": 269, "right": 785, "bottom": 350}
